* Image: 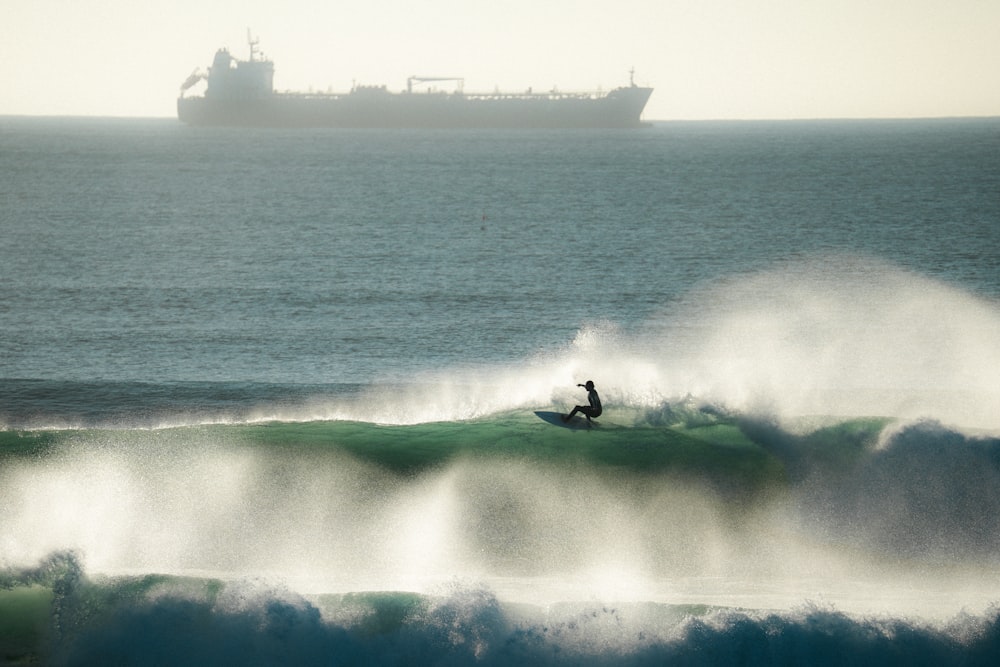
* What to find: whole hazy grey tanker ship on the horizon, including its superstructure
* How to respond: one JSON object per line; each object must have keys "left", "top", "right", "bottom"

{"left": 177, "top": 39, "right": 653, "bottom": 128}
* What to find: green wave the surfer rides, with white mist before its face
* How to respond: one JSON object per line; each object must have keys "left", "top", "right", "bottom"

{"left": 0, "top": 414, "right": 1000, "bottom": 589}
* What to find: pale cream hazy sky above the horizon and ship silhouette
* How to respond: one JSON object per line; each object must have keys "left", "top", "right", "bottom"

{"left": 0, "top": 0, "right": 1000, "bottom": 120}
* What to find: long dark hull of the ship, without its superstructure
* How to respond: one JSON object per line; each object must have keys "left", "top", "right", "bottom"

{"left": 177, "top": 86, "right": 652, "bottom": 128}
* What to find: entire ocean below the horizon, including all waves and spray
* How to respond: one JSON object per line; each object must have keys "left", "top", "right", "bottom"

{"left": 0, "top": 117, "right": 1000, "bottom": 665}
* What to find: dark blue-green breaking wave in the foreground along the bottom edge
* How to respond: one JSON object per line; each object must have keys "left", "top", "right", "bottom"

{"left": 0, "top": 553, "right": 1000, "bottom": 665}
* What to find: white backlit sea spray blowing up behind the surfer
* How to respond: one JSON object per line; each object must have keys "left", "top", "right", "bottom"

{"left": 294, "top": 255, "right": 1000, "bottom": 432}
